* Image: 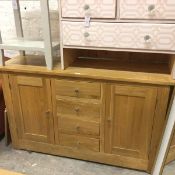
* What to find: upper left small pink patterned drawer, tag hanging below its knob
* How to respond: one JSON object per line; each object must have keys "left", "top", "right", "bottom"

{"left": 61, "top": 0, "right": 116, "bottom": 18}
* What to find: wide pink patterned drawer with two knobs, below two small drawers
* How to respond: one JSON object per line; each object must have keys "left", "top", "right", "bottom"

{"left": 63, "top": 22, "right": 175, "bottom": 51}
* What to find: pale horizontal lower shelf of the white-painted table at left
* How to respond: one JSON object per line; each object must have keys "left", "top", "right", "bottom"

{"left": 0, "top": 39, "right": 60, "bottom": 52}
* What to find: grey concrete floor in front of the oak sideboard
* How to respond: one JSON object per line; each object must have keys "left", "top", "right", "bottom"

{"left": 0, "top": 141, "right": 175, "bottom": 175}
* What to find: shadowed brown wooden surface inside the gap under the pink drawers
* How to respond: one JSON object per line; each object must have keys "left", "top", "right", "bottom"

{"left": 70, "top": 58, "right": 170, "bottom": 75}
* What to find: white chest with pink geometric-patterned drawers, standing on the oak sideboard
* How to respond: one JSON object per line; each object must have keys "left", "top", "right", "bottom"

{"left": 59, "top": 0, "right": 175, "bottom": 76}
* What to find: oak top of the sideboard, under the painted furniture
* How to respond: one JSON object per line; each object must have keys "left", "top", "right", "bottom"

{"left": 0, "top": 56, "right": 175, "bottom": 85}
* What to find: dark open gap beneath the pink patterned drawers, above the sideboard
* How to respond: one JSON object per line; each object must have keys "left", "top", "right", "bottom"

{"left": 64, "top": 49, "right": 171, "bottom": 75}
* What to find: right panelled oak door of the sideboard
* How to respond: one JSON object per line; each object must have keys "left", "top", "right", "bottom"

{"left": 105, "top": 85, "right": 157, "bottom": 160}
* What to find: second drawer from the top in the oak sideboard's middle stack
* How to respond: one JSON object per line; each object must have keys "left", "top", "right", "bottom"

{"left": 57, "top": 99, "right": 100, "bottom": 122}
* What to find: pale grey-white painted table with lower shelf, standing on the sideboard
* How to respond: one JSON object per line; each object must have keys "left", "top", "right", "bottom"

{"left": 0, "top": 0, "right": 60, "bottom": 70}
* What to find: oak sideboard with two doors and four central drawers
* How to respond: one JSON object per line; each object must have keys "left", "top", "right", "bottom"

{"left": 1, "top": 53, "right": 175, "bottom": 172}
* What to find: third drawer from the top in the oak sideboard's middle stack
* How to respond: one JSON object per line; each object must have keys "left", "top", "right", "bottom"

{"left": 59, "top": 116, "right": 100, "bottom": 136}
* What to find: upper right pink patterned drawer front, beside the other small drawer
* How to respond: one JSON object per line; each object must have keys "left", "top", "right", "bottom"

{"left": 120, "top": 0, "right": 175, "bottom": 20}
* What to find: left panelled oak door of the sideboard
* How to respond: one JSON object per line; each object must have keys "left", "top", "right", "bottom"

{"left": 10, "top": 75, "right": 54, "bottom": 143}
